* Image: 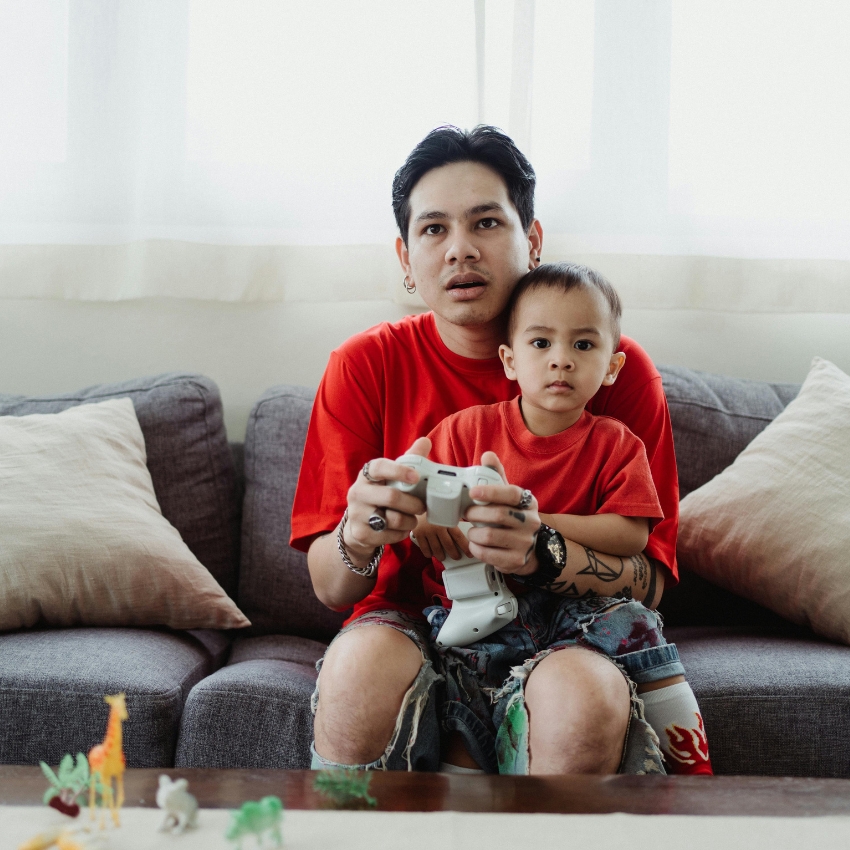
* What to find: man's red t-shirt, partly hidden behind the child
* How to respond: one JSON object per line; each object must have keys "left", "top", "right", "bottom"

{"left": 290, "top": 312, "right": 679, "bottom": 616}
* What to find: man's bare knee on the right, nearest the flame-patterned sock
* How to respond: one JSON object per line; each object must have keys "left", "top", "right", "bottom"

{"left": 525, "top": 648, "right": 631, "bottom": 773}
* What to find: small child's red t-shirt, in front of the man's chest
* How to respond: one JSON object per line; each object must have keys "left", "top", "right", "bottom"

{"left": 422, "top": 398, "right": 664, "bottom": 606}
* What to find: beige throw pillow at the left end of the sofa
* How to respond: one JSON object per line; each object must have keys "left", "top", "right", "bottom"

{"left": 0, "top": 398, "right": 250, "bottom": 630}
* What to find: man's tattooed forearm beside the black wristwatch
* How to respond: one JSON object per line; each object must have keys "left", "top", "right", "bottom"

{"left": 528, "top": 540, "right": 664, "bottom": 608}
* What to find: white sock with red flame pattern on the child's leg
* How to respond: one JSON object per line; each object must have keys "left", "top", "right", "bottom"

{"left": 639, "top": 682, "right": 714, "bottom": 775}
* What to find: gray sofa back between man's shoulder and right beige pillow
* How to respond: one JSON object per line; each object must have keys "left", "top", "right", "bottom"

{"left": 658, "top": 366, "right": 800, "bottom": 498}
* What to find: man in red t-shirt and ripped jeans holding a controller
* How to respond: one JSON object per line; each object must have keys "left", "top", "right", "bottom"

{"left": 292, "top": 127, "right": 678, "bottom": 773}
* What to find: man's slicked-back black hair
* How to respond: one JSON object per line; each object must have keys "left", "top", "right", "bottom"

{"left": 393, "top": 124, "right": 536, "bottom": 245}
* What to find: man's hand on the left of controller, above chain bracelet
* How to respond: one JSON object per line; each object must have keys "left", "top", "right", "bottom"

{"left": 342, "top": 437, "right": 431, "bottom": 566}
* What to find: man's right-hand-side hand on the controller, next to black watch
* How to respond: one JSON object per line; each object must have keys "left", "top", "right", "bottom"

{"left": 464, "top": 452, "right": 540, "bottom": 575}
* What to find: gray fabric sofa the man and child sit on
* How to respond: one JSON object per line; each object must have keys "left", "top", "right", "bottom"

{"left": 0, "top": 367, "right": 850, "bottom": 777}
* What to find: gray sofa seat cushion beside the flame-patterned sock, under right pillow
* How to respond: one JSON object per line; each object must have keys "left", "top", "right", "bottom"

{"left": 665, "top": 628, "right": 850, "bottom": 778}
